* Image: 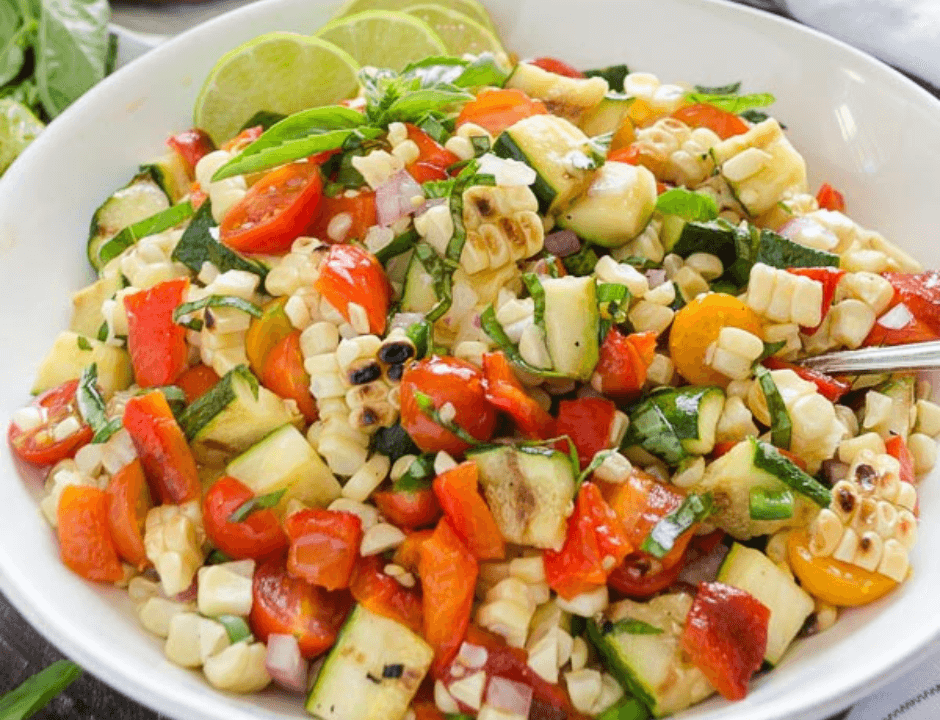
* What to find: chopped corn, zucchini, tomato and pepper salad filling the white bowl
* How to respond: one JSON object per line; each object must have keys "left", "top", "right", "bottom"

{"left": 8, "top": 2, "right": 940, "bottom": 720}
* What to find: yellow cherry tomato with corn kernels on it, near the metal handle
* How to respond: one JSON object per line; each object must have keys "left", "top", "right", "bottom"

{"left": 669, "top": 293, "right": 763, "bottom": 387}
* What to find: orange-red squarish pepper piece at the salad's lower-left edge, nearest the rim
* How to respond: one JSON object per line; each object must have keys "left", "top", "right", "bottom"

{"left": 56, "top": 485, "right": 124, "bottom": 582}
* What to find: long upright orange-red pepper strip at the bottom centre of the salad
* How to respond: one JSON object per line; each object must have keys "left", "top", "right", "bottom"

{"left": 418, "top": 518, "right": 479, "bottom": 672}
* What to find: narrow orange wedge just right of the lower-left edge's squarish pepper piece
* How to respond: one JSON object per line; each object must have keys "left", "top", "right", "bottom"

{"left": 106, "top": 459, "right": 153, "bottom": 570}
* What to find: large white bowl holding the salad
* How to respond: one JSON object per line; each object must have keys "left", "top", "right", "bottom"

{"left": 0, "top": 0, "right": 940, "bottom": 720}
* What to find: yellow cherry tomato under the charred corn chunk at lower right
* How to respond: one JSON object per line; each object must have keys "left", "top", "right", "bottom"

{"left": 787, "top": 530, "right": 897, "bottom": 607}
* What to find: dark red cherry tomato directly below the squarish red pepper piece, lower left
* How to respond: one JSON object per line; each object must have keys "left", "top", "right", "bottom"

{"left": 248, "top": 558, "right": 352, "bottom": 659}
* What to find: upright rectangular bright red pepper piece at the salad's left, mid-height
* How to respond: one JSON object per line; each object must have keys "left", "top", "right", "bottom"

{"left": 124, "top": 278, "right": 189, "bottom": 387}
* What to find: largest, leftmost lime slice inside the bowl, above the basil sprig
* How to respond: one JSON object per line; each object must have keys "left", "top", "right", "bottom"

{"left": 193, "top": 32, "right": 359, "bottom": 143}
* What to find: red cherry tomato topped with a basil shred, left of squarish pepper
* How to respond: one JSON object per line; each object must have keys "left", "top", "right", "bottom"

{"left": 202, "top": 475, "right": 287, "bottom": 560}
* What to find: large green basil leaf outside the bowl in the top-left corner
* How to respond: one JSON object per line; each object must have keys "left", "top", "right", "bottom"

{"left": 35, "top": 0, "right": 111, "bottom": 117}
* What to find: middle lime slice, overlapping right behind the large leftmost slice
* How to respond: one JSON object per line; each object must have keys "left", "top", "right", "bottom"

{"left": 317, "top": 10, "right": 447, "bottom": 70}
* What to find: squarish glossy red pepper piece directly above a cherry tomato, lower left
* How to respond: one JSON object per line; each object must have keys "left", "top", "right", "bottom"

{"left": 284, "top": 508, "right": 362, "bottom": 590}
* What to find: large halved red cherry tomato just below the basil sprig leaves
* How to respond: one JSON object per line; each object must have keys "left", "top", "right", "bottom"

{"left": 219, "top": 162, "right": 323, "bottom": 253}
